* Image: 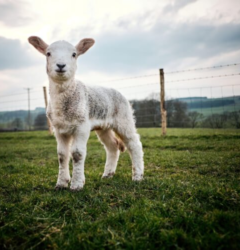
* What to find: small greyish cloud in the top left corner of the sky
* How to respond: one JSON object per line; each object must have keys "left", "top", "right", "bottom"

{"left": 0, "top": 0, "right": 33, "bottom": 27}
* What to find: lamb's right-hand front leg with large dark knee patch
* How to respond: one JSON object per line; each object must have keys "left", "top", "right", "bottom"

{"left": 70, "top": 131, "right": 90, "bottom": 191}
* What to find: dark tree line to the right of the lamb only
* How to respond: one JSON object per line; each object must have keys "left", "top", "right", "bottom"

{"left": 131, "top": 99, "right": 240, "bottom": 128}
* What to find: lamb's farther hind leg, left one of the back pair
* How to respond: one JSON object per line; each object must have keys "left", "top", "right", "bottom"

{"left": 96, "top": 129, "right": 125, "bottom": 178}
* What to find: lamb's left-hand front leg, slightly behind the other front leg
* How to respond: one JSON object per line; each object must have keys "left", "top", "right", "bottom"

{"left": 56, "top": 132, "right": 71, "bottom": 189}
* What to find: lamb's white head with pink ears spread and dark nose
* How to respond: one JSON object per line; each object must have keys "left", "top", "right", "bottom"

{"left": 28, "top": 36, "right": 94, "bottom": 83}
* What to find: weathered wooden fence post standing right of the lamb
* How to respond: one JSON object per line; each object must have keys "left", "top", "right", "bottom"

{"left": 159, "top": 69, "right": 167, "bottom": 136}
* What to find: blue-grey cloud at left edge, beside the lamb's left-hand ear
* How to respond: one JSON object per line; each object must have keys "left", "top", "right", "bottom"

{"left": 0, "top": 36, "right": 38, "bottom": 70}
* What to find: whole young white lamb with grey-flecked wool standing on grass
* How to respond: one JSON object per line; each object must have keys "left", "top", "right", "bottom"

{"left": 28, "top": 36, "right": 144, "bottom": 191}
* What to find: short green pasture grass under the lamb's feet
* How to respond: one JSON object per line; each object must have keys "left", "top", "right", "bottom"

{"left": 0, "top": 129, "right": 240, "bottom": 249}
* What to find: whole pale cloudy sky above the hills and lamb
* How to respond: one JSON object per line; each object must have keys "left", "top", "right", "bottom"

{"left": 0, "top": 0, "right": 240, "bottom": 111}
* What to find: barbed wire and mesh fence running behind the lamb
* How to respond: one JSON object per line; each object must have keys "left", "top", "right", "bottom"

{"left": 0, "top": 63, "right": 240, "bottom": 131}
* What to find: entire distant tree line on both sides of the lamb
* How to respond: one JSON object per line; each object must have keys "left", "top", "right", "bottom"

{"left": 0, "top": 97, "right": 240, "bottom": 130}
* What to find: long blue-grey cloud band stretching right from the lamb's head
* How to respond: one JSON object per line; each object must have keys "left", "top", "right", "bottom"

{"left": 73, "top": 19, "right": 240, "bottom": 73}
